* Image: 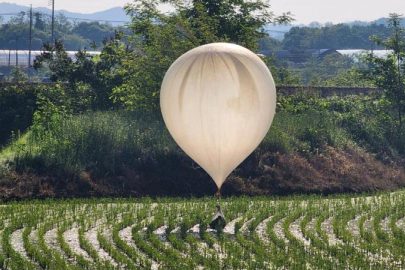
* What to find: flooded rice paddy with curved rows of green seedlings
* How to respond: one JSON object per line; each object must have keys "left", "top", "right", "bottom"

{"left": 0, "top": 191, "right": 405, "bottom": 269}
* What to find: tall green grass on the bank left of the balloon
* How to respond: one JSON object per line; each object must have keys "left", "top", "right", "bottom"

{"left": 4, "top": 111, "right": 178, "bottom": 176}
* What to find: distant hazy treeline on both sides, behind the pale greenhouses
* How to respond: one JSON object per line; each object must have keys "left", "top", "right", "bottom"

{"left": 0, "top": 7, "right": 392, "bottom": 53}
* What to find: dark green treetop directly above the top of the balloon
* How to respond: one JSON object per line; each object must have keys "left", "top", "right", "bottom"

{"left": 176, "top": 0, "right": 291, "bottom": 51}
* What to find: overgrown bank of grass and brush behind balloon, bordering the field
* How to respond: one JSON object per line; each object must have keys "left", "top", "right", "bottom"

{"left": 0, "top": 94, "right": 404, "bottom": 198}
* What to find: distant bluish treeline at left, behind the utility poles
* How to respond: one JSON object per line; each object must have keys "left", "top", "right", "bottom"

{"left": 0, "top": 11, "right": 125, "bottom": 50}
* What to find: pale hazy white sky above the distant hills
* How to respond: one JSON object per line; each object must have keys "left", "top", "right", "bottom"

{"left": 5, "top": 0, "right": 405, "bottom": 24}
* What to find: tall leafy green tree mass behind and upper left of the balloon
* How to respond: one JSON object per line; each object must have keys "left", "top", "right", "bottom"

{"left": 113, "top": 0, "right": 291, "bottom": 110}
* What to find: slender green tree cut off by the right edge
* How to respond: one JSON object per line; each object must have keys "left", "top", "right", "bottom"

{"left": 363, "top": 13, "right": 405, "bottom": 149}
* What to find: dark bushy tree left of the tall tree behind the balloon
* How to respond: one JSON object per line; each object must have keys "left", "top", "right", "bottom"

{"left": 34, "top": 32, "right": 129, "bottom": 110}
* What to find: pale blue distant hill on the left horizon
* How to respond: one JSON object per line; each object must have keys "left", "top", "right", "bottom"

{"left": 0, "top": 3, "right": 130, "bottom": 25}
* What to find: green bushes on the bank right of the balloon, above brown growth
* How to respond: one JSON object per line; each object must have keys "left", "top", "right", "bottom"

{"left": 277, "top": 93, "right": 405, "bottom": 158}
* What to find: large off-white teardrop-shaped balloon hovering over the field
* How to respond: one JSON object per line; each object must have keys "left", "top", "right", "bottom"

{"left": 160, "top": 43, "right": 276, "bottom": 189}
